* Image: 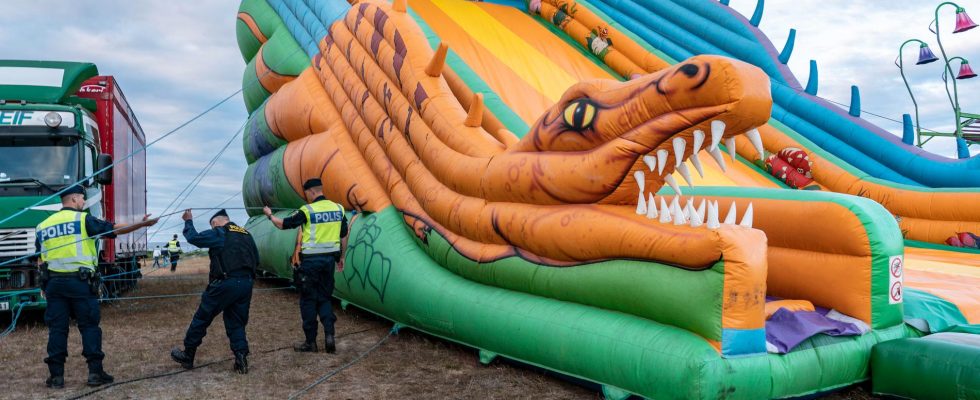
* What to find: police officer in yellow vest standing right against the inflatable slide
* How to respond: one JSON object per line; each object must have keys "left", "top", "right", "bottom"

{"left": 263, "top": 179, "right": 347, "bottom": 353}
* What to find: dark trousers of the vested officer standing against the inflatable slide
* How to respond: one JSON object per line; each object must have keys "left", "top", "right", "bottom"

{"left": 298, "top": 253, "right": 337, "bottom": 343}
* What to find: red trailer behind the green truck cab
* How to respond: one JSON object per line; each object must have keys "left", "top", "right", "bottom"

{"left": 77, "top": 75, "right": 147, "bottom": 266}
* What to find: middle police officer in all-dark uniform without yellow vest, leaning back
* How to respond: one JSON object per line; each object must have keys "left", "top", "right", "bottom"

{"left": 170, "top": 209, "right": 259, "bottom": 374}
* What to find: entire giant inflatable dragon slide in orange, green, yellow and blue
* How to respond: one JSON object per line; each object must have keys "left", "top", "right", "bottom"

{"left": 237, "top": 0, "right": 980, "bottom": 399}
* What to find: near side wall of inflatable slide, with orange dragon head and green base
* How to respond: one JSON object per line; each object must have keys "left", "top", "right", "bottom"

{"left": 238, "top": 0, "right": 913, "bottom": 399}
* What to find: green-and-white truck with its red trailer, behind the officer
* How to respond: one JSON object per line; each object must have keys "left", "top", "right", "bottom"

{"left": 0, "top": 60, "right": 146, "bottom": 312}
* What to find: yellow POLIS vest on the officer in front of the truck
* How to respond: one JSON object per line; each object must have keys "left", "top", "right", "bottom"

{"left": 37, "top": 210, "right": 98, "bottom": 272}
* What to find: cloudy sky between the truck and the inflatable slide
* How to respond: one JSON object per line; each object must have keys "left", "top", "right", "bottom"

{"left": 0, "top": 0, "right": 253, "bottom": 247}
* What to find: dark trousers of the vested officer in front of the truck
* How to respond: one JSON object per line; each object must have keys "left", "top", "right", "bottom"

{"left": 44, "top": 274, "right": 105, "bottom": 376}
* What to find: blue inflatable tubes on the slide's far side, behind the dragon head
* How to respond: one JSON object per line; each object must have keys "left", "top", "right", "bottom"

{"left": 589, "top": 0, "right": 980, "bottom": 187}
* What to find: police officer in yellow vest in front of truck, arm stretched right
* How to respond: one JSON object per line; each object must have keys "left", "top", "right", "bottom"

{"left": 35, "top": 186, "right": 157, "bottom": 389}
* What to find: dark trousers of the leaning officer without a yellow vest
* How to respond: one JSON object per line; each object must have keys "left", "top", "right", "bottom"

{"left": 184, "top": 278, "right": 252, "bottom": 354}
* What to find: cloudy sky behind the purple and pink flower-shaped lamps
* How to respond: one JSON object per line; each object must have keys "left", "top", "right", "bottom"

{"left": 731, "top": 0, "right": 980, "bottom": 157}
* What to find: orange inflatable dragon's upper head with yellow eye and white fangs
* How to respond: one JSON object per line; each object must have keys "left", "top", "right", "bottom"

{"left": 511, "top": 56, "right": 772, "bottom": 204}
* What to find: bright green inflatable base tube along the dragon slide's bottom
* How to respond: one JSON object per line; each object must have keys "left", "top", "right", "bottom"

{"left": 248, "top": 207, "right": 915, "bottom": 399}
